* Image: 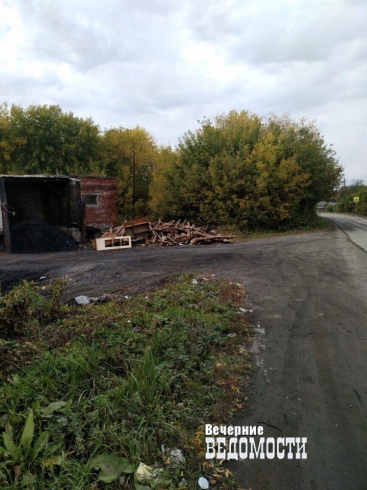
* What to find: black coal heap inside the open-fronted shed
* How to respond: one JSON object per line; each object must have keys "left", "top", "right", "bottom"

{"left": 10, "top": 220, "right": 79, "bottom": 253}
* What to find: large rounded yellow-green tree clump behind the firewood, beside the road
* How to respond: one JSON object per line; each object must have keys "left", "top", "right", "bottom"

{"left": 151, "top": 111, "right": 342, "bottom": 228}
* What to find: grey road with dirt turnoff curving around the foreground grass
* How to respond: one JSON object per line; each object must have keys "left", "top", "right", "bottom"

{"left": 0, "top": 221, "right": 367, "bottom": 490}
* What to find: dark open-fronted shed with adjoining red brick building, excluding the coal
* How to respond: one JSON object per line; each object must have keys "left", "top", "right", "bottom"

{"left": 0, "top": 175, "right": 116, "bottom": 252}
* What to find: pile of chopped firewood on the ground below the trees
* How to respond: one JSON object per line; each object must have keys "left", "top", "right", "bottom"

{"left": 114, "top": 219, "right": 236, "bottom": 245}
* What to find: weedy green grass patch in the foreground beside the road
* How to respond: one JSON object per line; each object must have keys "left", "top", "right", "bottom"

{"left": 0, "top": 276, "right": 249, "bottom": 490}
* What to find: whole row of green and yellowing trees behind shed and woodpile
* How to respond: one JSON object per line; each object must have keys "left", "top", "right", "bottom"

{"left": 0, "top": 103, "right": 342, "bottom": 229}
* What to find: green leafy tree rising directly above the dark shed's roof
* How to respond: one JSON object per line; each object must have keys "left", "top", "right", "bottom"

{"left": 10, "top": 105, "right": 100, "bottom": 175}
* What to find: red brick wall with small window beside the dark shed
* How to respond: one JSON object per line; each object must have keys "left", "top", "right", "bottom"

{"left": 80, "top": 177, "right": 116, "bottom": 228}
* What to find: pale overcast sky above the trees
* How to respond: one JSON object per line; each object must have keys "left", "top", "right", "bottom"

{"left": 0, "top": 0, "right": 367, "bottom": 181}
